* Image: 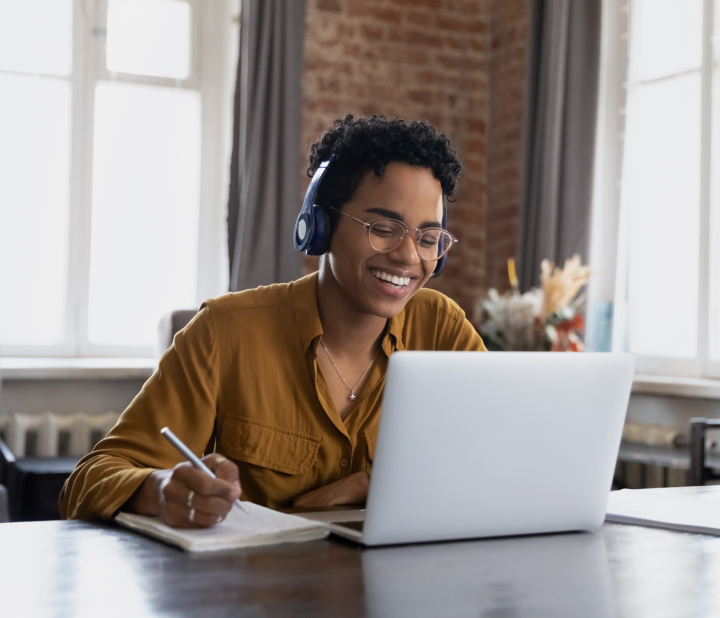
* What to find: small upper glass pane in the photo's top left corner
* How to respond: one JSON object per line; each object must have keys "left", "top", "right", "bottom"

{"left": 0, "top": 0, "right": 73, "bottom": 76}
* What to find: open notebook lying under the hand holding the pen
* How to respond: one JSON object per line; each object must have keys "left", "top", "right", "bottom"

{"left": 115, "top": 502, "right": 328, "bottom": 552}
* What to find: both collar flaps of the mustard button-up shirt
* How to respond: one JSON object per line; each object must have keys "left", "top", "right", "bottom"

{"left": 292, "top": 272, "right": 405, "bottom": 357}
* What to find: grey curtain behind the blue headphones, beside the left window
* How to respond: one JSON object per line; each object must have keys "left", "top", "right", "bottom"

{"left": 228, "top": 0, "right": 305, "bottom": 291}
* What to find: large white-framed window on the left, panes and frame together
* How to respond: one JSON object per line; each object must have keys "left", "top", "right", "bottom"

{"left": 0, "top": 0, "right": 238, "bottom": 356}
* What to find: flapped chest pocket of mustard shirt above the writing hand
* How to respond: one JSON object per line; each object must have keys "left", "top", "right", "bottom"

{"left": 220, "top": 416, "right": 321, "bottom": 508}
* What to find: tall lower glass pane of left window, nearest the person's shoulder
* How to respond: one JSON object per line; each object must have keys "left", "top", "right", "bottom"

{"left": 88, "top": 83, "right": 200, "bottom": 346}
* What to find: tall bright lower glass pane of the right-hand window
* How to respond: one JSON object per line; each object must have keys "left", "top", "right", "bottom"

{"left": 623, "top": 71, "right": 700, "bottom": 358}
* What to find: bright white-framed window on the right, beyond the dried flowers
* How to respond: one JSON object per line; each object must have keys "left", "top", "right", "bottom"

{"left": 593, "top": 0, "right": 720, "bottom": 377}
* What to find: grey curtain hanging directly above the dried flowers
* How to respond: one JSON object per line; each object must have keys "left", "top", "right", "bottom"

{"left": 517, "top": 0, "right": 602, "bottom": 291}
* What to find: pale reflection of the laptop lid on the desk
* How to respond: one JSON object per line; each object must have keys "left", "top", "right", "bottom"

{"left": 362, "top": 532, "right": 614, "bottom": 618}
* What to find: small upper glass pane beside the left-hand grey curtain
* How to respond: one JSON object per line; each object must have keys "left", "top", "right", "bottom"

{"left": 107, "top": 0, "right": 191, "bottom": 79}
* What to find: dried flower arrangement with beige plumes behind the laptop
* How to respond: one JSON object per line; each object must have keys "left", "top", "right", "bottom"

{"left": 473, "top": 255, "right": 590, "bottom": 352}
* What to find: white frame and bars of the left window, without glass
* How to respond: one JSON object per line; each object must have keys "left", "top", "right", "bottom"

{"left": 0, "top": 0, "right": 235, "bottom": 358}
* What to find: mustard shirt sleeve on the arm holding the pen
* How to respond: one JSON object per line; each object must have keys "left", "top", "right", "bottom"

{"left": 58, "top": 306, "right": 218, "bottom": 519}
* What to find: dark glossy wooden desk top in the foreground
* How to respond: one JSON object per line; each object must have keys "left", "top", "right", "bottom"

{"left": 0, "top": 487, "right": 720, "bottom": 618}
